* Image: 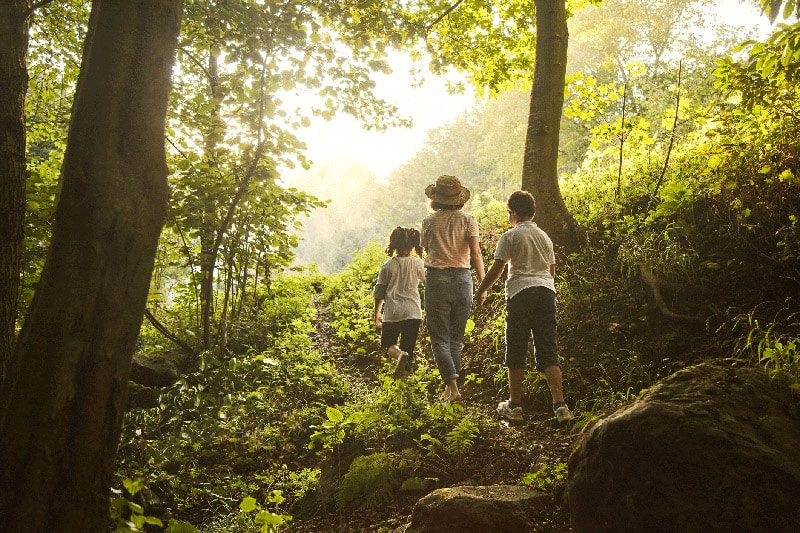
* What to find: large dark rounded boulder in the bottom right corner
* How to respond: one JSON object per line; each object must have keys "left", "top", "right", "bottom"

{"left": 568, "top": 360, "right": 800, "bottom": 533}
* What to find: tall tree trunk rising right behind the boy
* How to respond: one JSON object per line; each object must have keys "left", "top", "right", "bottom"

{"left": 522, "top": 0, "right": 579, "bottom": 251}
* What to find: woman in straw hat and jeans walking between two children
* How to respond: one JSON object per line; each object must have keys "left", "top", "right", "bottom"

{"left": 422, "top": 176, "right": 484, "bottom": 402}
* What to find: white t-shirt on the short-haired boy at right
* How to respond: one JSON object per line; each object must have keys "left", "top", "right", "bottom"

{"left": 494, "top": 220, "right": 556, "bottom": 300}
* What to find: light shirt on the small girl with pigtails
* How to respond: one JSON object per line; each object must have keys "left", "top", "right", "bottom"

{"left": 376, "top": 256, "right": 425, "bottom": 322}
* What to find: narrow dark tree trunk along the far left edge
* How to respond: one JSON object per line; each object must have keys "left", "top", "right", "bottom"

{"left": 0, "top": 0, "right": 30, "bottom": 383}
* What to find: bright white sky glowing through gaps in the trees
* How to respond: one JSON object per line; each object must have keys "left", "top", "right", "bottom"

{"left": 282, "top": 0, "right": 770, "bottom": 271}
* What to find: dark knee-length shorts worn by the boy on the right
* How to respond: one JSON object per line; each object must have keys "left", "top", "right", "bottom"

{"left": 505, "top": 287, "right": 561, "bottom": 372}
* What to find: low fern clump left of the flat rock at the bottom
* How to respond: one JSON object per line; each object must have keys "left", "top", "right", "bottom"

{"left": 336, "top": 452, "right": 397, "bottom": 510}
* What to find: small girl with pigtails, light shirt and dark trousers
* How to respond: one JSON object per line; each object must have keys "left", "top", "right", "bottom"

{"left": 373, "top": 227, "right": 425, "bottom": 379}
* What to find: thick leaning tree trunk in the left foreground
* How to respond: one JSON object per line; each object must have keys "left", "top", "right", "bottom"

{"left": 0, "top": 0, "right": 182, "bottom": 532}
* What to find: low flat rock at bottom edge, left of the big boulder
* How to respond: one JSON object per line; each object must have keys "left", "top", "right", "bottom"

{"left": 405, "top": 485, "right": 550, "bottom": 533}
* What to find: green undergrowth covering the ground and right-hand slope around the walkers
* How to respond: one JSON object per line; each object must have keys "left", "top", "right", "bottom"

{"left": 112, "top": 44, "right": 800, "bottom": 531}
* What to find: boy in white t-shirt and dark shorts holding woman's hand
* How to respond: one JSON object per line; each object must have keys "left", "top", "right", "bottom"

{"left": 476, "top": 191, "right": 572, "bottom": 423}
